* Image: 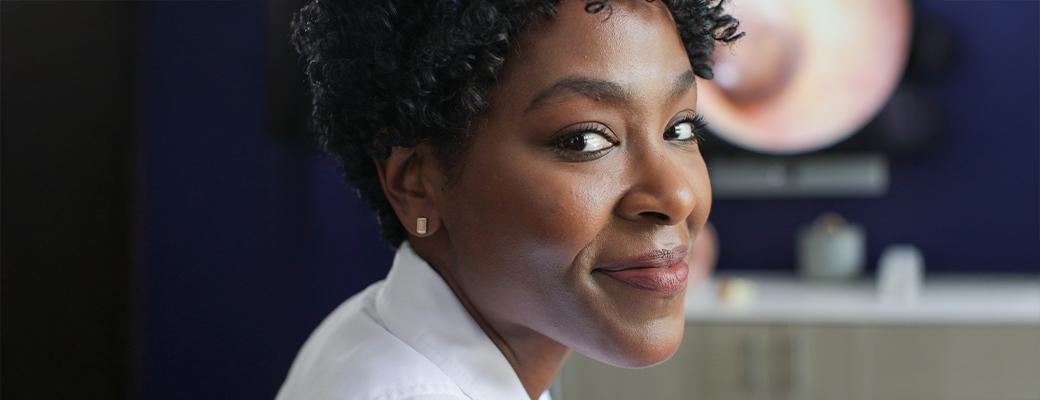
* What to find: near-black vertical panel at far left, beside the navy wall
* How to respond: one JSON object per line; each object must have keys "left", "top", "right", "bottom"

{"left": 0, "top": 1, "right": 137, "bottom": 399}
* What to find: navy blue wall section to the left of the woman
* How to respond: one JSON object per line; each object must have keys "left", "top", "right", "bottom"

{"left": 138, "top": 1, "right": 392, "bottom": 399}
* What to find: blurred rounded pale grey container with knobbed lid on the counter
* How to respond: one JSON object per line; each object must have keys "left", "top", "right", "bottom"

{"left": 798, "top": 213, "right": 866, "bottom": 279}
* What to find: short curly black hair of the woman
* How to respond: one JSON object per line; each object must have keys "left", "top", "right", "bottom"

{"left": 292, "top": 0, "right": 744, "bottom": 247}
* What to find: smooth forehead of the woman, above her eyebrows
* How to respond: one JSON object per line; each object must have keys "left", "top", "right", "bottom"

{"left": 493, "top": 0, "right": 691, "bottom": 111}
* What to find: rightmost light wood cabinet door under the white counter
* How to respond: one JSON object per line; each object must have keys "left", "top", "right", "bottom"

{"left": 872, "top": 325, "right": 1040, "bottom": 400}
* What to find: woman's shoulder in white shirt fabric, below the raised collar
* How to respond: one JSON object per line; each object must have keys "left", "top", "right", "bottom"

{"left": 277, "top": 283, "right": 468, "bottom": 400}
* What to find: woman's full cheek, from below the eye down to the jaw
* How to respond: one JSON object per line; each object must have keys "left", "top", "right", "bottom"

{"left": 445, "top": 151, "right": 620, "bottom": 314}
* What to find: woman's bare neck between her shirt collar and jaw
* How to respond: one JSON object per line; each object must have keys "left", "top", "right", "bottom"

{"left": 411, "top": 234, "right": 570, "bottom": 399}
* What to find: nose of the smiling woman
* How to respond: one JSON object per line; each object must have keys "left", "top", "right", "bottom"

{"left": 617, "top": 144, "right": 697, "bottom": 225}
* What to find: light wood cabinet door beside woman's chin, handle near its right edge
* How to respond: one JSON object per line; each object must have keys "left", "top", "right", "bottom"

{"left": 561, "top": 325, "right": 770, "bottom": 400}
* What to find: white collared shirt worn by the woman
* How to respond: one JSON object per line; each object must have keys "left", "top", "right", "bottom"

{"left": 276, "top": 242, "right": 551, "bottom": 400}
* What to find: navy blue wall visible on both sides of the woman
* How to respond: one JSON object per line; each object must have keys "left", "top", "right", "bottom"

{"left": 138, "top": 1, "right": 1040, "bottom": 399}
